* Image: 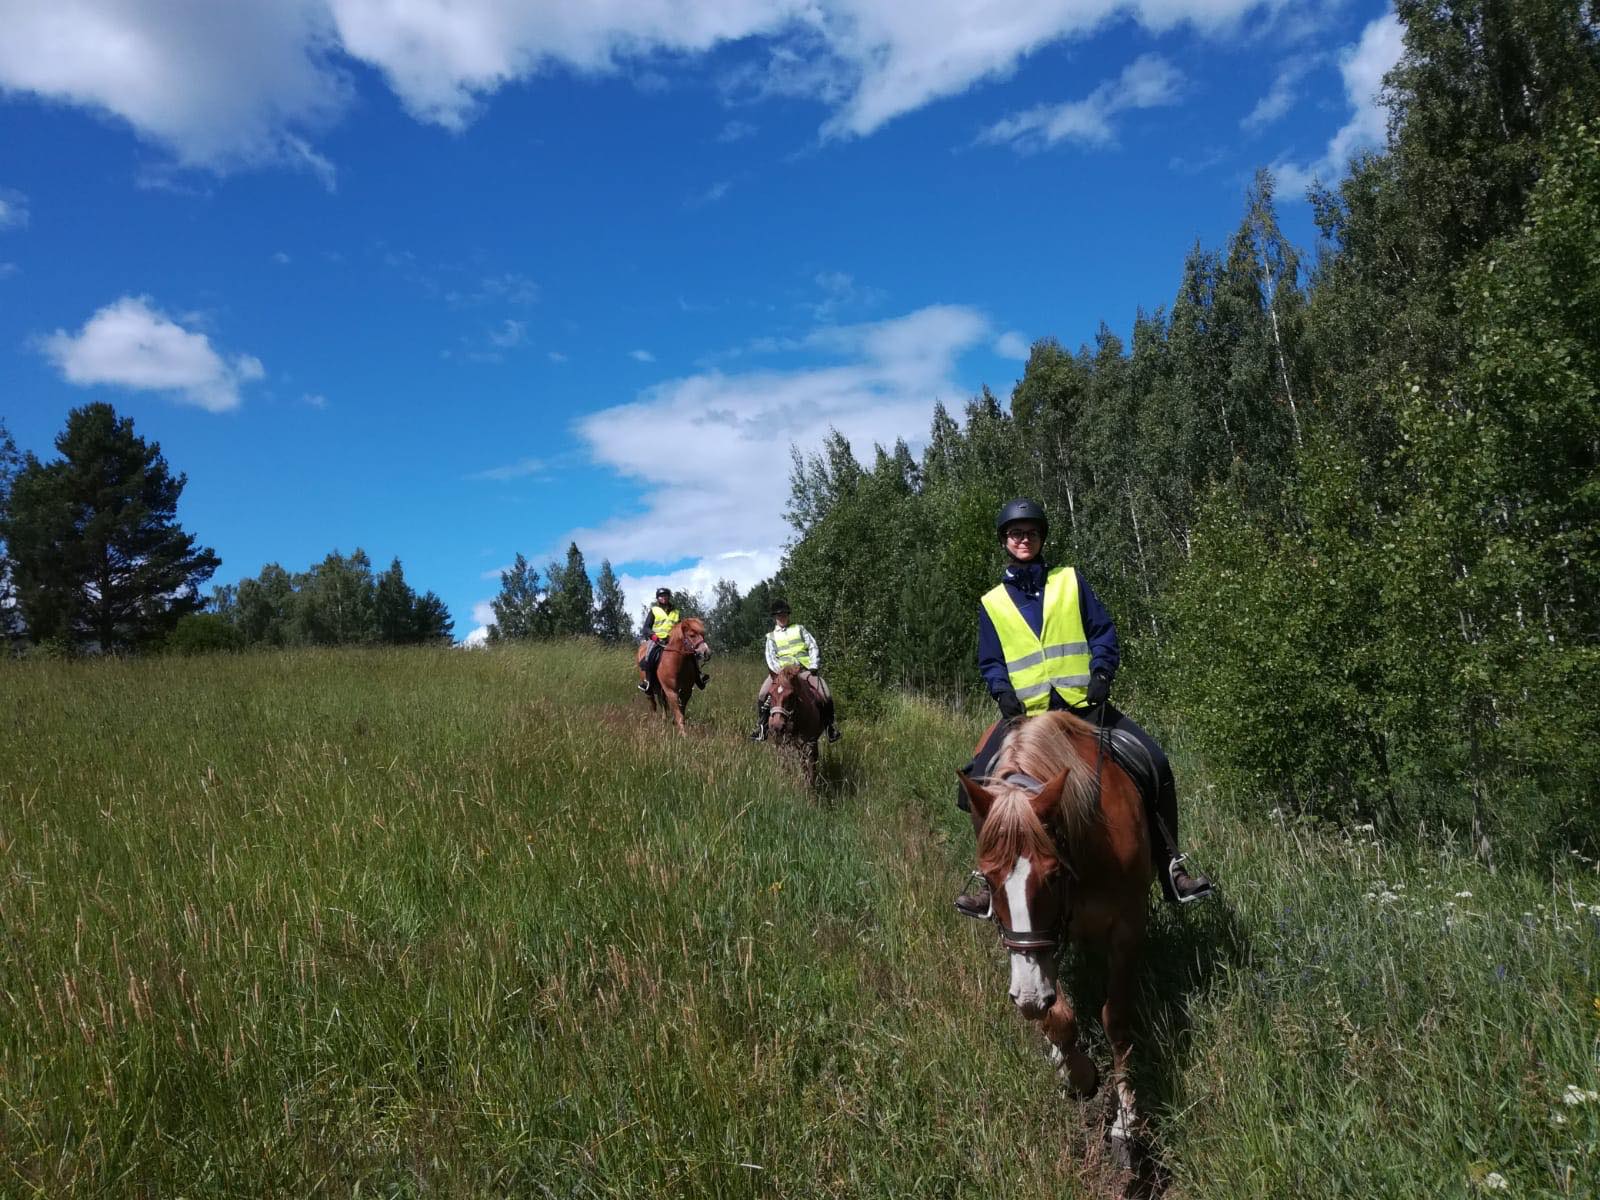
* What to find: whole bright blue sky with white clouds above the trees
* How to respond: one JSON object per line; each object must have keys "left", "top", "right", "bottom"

{"left": 0, "top": 0, "right": 1400, "bottom": 637}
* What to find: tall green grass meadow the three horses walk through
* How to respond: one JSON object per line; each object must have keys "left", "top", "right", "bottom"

{"left": 0, "top": 645, "right": 1600, "bottom": 1200}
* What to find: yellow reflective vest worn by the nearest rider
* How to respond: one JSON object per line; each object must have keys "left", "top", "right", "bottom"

{"left": 984, "top": 566, "right": 1090, "bottom": 717}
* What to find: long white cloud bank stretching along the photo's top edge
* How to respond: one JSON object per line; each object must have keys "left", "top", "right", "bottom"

{"left": 0, "top": 0, "right": 1285, "bottom": 170}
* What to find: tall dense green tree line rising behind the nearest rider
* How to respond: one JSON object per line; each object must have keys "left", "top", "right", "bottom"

{"left": 768, "top": 0, "right": 1600, "bottom": 850}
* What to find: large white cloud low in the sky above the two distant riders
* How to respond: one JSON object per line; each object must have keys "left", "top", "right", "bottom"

{"left": 560, "top": 306, "right": 994, "bottom": 603}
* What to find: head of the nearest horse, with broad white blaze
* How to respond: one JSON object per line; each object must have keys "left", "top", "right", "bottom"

{"left": 960, "top": 773, "right": 1069, "bottom": 1019}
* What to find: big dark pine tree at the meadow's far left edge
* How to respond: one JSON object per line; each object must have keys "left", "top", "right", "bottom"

{"left": 3, "top": 403, "right": 221, "bottom": 651}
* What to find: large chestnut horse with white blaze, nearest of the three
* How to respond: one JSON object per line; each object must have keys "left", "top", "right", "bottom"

{"left": 960, "top": 712, "right": 1154, "bottom": 1165}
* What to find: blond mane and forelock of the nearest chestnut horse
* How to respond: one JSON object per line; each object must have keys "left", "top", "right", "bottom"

{"left": 978, "top": 712, "right": 1102, "bottom": 870}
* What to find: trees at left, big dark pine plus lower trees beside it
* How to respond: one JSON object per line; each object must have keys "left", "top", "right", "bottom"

{"left": 0, "top": 403, "right": 453, "bottom": 653}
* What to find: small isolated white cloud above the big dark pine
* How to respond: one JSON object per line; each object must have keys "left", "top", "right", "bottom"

{"left": 38, "top": 296, "right": 266, "bottom": 413}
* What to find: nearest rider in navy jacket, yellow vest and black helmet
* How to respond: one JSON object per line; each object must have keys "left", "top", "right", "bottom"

{"left": 955, "top": 499, "right": 1211, "bottom": 917}
